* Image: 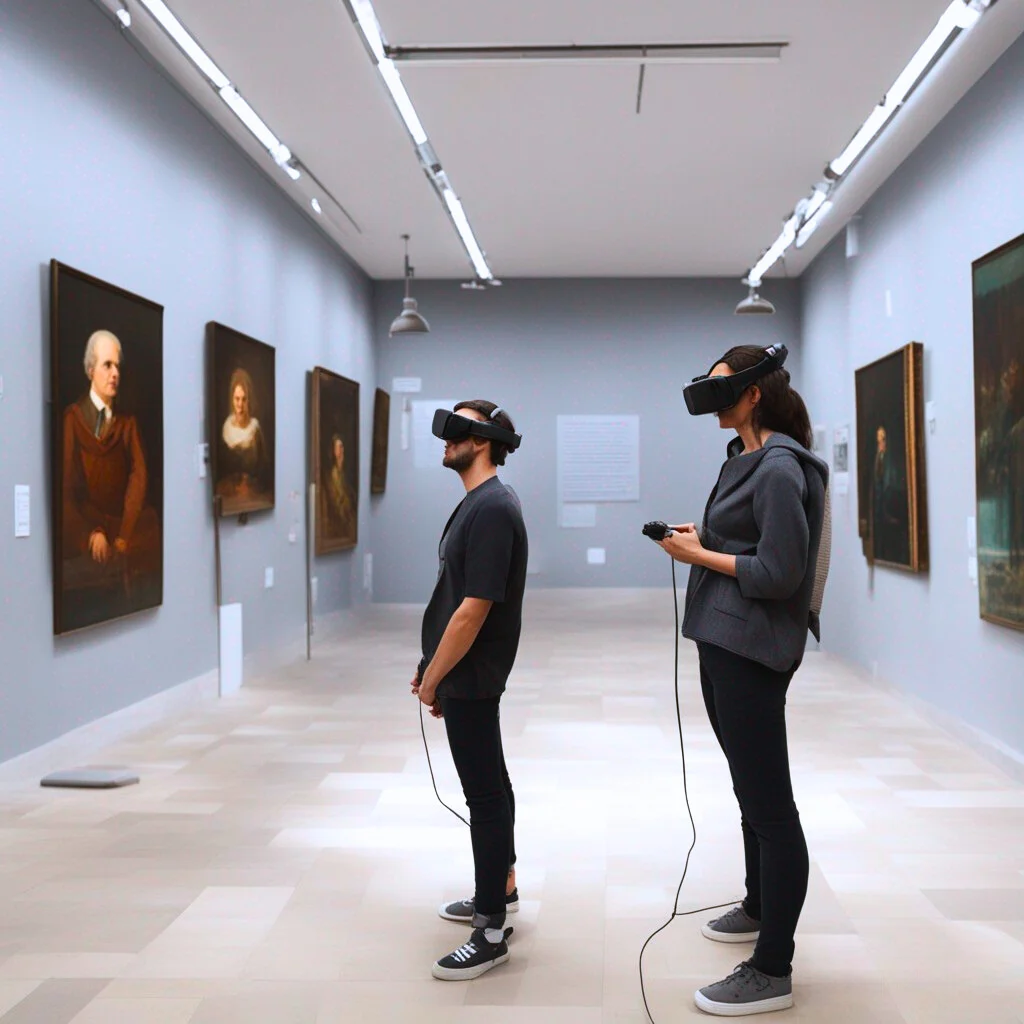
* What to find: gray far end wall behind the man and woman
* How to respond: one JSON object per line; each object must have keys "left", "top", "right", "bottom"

{"left": 373, "top": 280, "right": 800, "bottom": 602}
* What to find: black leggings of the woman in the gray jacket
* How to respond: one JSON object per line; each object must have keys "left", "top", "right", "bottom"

{"left": 697, "top": 643, "right": 808, "bottom": 978}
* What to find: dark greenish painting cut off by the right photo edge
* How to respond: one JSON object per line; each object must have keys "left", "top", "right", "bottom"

{"left": 973, "top": 236, "right": 1024, "bottom": 630}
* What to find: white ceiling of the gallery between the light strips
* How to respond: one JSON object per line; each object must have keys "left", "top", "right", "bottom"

{"left": 132, "top": 0, "right": 1018, "bottom": 280}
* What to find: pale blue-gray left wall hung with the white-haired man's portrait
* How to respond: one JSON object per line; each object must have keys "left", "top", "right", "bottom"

{"left": 0, "top": 0, "right": 375, "bottom": 759}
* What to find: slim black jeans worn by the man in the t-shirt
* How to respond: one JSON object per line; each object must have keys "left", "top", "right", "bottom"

{"left": 440, "top": 696, "right": 515, "bottom": 928}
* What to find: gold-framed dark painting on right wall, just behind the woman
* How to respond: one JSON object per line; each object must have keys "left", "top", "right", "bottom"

{"left": 856, "top": 341, "right": 928, "bottom": 572}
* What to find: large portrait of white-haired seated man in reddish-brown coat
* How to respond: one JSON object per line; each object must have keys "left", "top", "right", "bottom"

{"left": 50, "top": 260, "right": 164, "bottom": 635}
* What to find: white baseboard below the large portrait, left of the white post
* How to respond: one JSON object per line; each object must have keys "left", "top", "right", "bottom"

{"left": 0, "top": 669, "right": 218, "bottom": 783}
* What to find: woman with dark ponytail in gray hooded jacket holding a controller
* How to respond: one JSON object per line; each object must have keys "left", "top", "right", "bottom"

{"left": 660, "top": 346, "right": 828, "bottom": 1017}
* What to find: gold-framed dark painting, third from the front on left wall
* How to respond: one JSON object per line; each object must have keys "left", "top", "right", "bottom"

{"left": 310, "top": 367, "right": 359, "bottom": 555}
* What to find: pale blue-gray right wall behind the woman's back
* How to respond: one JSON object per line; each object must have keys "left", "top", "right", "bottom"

{"left": 803, "top": 34, "right": 1024, "bottom": 752}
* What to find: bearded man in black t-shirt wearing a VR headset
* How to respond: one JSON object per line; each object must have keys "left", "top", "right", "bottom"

{"left": 413, "top": 400, "right": 527, "bottom": 981}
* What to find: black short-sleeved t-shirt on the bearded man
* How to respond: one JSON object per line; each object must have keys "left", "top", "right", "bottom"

{"left": 422, "top": 476, "right": 527, "bottom": 699}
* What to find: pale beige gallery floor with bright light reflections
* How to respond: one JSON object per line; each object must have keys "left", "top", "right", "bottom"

{"left": 0, "top": 591, "right": 1024, "bottom": 1024}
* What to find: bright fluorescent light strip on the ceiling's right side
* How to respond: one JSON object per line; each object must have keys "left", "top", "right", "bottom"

{"left": 744, "top": 0, "right": 992, "bottom": 280}
